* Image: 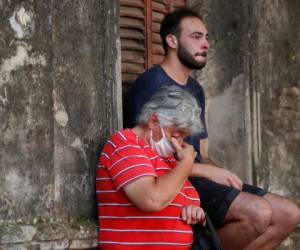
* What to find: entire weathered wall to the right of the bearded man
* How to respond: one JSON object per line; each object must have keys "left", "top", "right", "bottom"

{"left": 188, "top": 0, "right": 300, "bottom": 250}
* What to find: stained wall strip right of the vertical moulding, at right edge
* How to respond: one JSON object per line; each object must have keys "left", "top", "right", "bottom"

{"left": 249, "top": 0, "right": 300, "bottom": 246}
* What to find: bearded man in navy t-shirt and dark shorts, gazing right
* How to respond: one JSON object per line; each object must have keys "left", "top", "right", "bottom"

{"left": 124, "top": 9, "right": 300, "bottom": 250}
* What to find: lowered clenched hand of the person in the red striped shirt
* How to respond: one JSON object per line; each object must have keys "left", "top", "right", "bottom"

{"left": 181, "top": 205, "right": 205, "bottom": 225}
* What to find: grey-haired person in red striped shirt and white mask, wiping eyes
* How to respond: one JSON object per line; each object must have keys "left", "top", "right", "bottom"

{"left": 96, "top": 86, "right": 204, "bottom": 250}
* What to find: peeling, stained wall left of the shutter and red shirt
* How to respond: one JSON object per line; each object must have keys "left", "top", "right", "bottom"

{"left": 0, "top": 0, "right": 122, "bottom": 249}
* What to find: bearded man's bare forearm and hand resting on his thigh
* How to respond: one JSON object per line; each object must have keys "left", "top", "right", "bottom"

{"left": 190, "top": 139, "right": 243, "bottom": 190}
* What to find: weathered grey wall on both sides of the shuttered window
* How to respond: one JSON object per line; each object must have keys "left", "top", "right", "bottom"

{"left": 0, "top": 0, "right": 300, "bottom": 249}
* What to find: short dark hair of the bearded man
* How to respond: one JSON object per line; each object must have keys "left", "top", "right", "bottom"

{"left": 160, "top": 8, "right": 201, "bottom": 54}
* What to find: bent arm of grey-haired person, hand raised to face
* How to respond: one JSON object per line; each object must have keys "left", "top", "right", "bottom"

{"left": 124, "top": 138, "right": 195, "bottom": 212}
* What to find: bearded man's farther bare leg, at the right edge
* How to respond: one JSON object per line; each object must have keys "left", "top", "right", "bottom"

{"left": 245, "top": 194, "right": 300, "bottom": 250}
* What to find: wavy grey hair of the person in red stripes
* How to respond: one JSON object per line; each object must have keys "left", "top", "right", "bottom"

{"left": 137, "top": 85, "right": 203, "bottom": 134}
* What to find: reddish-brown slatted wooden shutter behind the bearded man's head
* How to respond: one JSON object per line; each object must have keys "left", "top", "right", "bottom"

{"left": 120, "top": 0, "right": 186, "bottom": 92}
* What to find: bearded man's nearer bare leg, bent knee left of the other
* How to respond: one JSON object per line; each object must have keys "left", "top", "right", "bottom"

{"left": 218, "top": 192, "right": 272, "bottom": 250}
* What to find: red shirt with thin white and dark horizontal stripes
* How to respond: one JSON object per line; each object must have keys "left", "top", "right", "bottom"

{"left": 96, "top": 129, "right": 200, "bottom": 250}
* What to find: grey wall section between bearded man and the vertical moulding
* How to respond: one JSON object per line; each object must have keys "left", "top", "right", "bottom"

{"left": 188, "top": 0, "right": 252, "bottom": 182}
